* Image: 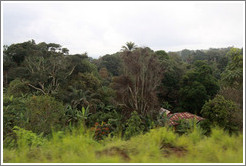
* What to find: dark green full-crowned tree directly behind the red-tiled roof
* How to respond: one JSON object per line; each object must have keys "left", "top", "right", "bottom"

{"left": 180, "top": 61, "right": 219, "bottom": 114}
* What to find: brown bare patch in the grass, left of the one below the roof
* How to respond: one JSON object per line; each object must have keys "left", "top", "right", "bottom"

{"left": 96, "top": 147, "right": 130, "bottom": 161}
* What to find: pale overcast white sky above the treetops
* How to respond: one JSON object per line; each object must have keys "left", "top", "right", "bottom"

{"left": 1, "top": 1, "right": 245, "bottom": 58}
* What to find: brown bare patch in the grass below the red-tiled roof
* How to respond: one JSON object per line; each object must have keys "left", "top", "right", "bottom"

{"left": 160, "top": 144, "right": 187, "bottom": 157}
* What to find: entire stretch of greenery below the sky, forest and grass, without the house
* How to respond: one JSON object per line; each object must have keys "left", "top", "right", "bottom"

{"left": 3, "top": 40, "right": 243, "bottom": 163}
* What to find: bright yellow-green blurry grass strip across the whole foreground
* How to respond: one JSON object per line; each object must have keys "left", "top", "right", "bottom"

{"left": 3, "top": 128, "right": 243, "bottom": 163}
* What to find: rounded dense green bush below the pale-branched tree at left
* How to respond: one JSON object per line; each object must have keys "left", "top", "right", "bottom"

{"left": 27, "top": 96, "right": 65, "bottom": 135}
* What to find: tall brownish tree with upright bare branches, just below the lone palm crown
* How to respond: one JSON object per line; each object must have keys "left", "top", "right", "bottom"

{"left": 113, "top": 48, "right": 162, "bottom": 115}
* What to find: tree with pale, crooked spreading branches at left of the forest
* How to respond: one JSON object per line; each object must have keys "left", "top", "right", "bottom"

{"left": 25, "top": 55, "right": 75, "bottom": 94}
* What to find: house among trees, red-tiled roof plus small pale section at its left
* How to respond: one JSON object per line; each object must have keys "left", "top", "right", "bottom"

{"left": 160, "top": 108, "right": 204, "bottom": 127}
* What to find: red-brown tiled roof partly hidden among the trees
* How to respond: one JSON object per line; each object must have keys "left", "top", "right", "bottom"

{"left": 167, "top": 112, "right": 204, "bottom": 126}
